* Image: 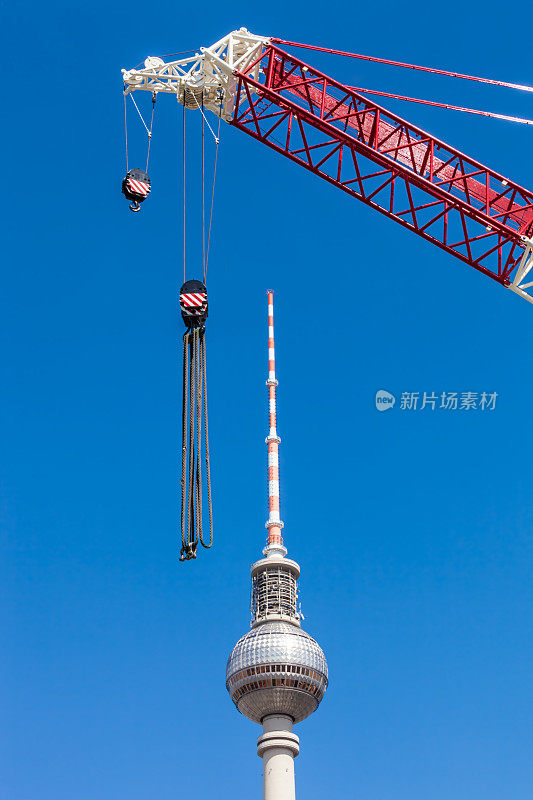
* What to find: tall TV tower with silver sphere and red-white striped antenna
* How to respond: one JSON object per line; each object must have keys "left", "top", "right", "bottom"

{"left": 226, "top": 292, "right": 328, "bottom": 800}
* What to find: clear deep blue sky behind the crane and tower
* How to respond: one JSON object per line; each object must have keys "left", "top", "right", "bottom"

{"left": 0, "top": 0, "right": 533, "bottom": 800}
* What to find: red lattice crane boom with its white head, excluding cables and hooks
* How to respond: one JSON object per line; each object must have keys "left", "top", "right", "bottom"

{"left": 122, "top": 28, "right": 533, "bottom": 303}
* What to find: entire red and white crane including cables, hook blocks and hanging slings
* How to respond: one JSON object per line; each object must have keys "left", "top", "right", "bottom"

{"left": 122, "top": 28, "right": 533, "bottom": 561}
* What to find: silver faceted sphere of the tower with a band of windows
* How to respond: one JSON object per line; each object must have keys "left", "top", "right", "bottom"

{"left": 226, "top": 622, "right": 328, "bottom": 722}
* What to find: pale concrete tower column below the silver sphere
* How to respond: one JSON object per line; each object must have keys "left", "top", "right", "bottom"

{"left": 257, "top": 714, "right": 300, "bottom": 800}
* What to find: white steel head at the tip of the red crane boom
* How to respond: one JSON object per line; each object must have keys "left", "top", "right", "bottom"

{"left": 122, "top": 28, "right": 270, "bottom": 122}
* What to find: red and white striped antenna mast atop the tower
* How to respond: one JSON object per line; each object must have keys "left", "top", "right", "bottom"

{"left": 265, "top": 291, "right": 283, "bottom": 547}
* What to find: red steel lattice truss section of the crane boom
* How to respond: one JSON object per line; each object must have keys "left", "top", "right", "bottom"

{"left": 232, "top": 45, "right": 533, "bottom": 285}
